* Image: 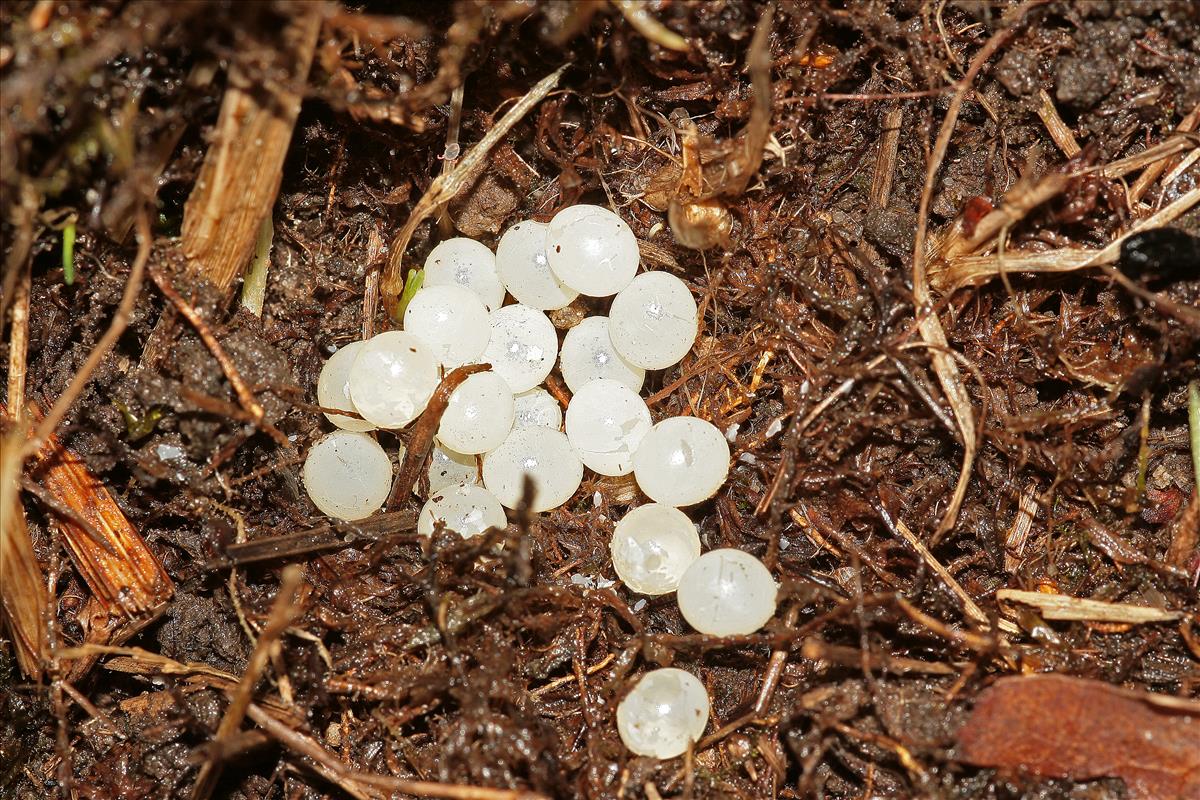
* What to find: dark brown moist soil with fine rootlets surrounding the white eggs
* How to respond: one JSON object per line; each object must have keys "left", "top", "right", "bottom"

{"left": 0, "top": 0, "right": 1200, "bottom": 799}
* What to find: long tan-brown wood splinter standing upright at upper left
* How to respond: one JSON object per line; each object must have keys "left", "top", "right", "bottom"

{"left": 181, "top": 8, "right": 322, "bottom": 297}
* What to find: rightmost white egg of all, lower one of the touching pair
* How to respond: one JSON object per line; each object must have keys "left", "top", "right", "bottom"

{"left": 676, "top": 548, "right": 778, "bottom": 636}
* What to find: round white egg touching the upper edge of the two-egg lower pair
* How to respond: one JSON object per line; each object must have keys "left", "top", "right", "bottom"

{"left": 634, "top": 416, "right": 730, "bottom": 506}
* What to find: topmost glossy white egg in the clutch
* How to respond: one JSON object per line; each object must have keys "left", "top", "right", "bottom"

{"left": 546, "top": 205, "right": 640, "bottom": 297}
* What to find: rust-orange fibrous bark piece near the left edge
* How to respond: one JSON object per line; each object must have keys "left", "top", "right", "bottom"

{"left": 30, "top": 411, "right": 174, "bottom": 619}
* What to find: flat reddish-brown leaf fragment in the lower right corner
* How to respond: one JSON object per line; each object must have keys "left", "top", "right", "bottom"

{"left": 959, "top": 675, "right": 1200, "bottom": 800}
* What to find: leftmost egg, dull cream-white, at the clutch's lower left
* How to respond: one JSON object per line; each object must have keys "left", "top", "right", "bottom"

{"left": 301, "top": 431, "right": 391, "bottom": 521}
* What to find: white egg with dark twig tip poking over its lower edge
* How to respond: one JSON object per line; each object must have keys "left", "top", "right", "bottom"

{"left": 484, "top": 428, "right": 583, "bottom": 511}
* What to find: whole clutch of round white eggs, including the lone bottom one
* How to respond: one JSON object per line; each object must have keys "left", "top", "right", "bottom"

{"left": 304, "top": 205, "right": 776, "bottom": 758}
